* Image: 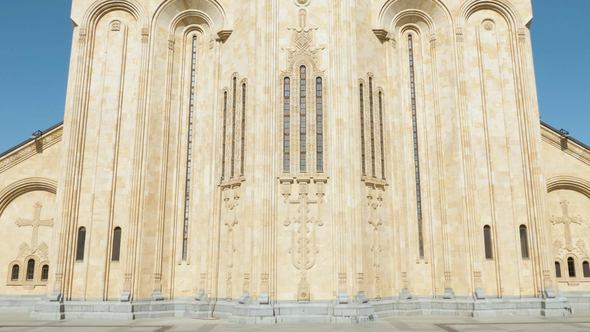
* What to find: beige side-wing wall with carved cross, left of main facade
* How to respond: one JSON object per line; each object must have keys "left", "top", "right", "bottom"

{"left": 0, "top": 126, "right": 62, "bottom": 295}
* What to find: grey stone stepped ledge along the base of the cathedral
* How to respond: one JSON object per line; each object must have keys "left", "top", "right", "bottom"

{"left": 9, "top": 296, "right": 576, "bottom": 324}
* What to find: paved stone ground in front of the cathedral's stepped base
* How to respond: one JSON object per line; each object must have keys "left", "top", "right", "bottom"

{"left": 0, "top": 313, "right": 590, "bottom": 332}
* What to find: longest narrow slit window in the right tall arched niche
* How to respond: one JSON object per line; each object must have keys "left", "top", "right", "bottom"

{"left": 408, "top": 34, "right": 424, "bottom": 257}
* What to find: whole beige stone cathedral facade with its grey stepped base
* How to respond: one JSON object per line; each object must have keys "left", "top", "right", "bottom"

{"left": 0, "top": 0, "right": 590, "bottom": 322}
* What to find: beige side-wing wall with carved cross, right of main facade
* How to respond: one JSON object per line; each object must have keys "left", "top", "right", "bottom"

{"left": 542, "top": 127, "right": 590, "bottom": 292}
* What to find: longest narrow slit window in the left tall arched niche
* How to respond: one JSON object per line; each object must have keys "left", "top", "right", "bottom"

{"left": 182, "top": 36, "right": 197, "bottom": 261}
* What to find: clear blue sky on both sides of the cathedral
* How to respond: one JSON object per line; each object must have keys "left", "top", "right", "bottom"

{"left": 0, "top": 0, "right": 590, "bottom": 152}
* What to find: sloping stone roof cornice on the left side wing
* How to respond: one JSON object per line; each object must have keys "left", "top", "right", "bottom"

{"left": 0, "top": 123, "right": 63, "bottom": 173}
